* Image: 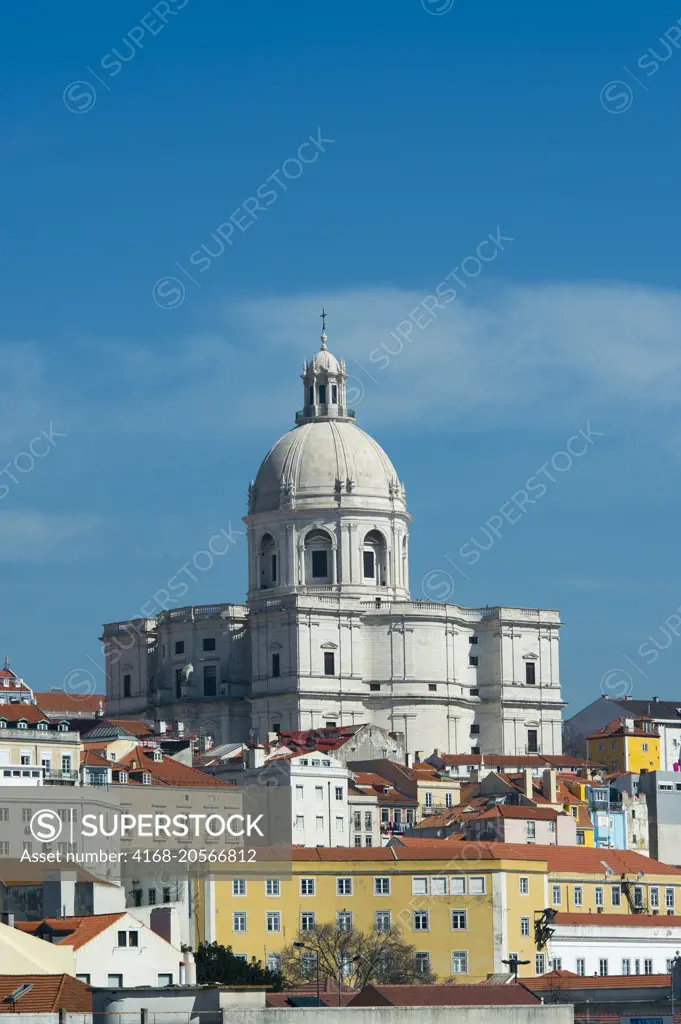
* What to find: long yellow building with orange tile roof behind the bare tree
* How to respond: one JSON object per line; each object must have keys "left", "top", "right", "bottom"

{"left": 204, "top": 839, "right": 681, "bottom": 982}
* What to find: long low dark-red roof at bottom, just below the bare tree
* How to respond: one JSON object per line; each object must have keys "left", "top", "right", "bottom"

{"left": 349, "top": 983, "right": 541, "bottom": 1007}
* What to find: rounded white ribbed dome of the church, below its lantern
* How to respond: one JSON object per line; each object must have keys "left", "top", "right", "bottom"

{"left": 250, "top": 417, "right": 405, "bottom": 514}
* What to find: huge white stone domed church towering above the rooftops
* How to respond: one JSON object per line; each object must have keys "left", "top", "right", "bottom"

{"left": 102, "top": 323, "right": 563, "bottom": 754}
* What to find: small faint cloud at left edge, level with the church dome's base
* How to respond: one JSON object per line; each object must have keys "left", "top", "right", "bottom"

{"left": 0, "top": 509, "right": 102, "bottom": 562}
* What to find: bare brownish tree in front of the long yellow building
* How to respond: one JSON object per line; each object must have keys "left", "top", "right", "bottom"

{"left": 281, "top": 925, "right": 435, "bottom": 988}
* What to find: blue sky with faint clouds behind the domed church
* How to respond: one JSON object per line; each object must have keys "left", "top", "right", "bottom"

{"left": 0, "top": 0, "right": 681, "bottom": 713}
